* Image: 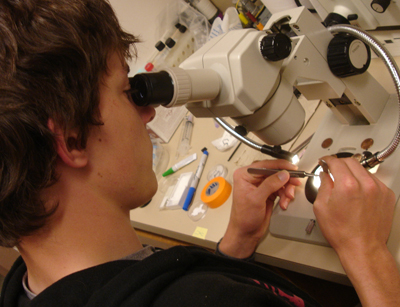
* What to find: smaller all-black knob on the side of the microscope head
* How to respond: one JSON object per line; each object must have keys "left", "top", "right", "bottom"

{"left": 260, "top": 33, "right": 292, "bottom": 62}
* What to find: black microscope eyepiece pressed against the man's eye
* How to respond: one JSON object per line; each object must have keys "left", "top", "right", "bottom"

{"left": 129, "top": 71, "right": 174, "bottom": 106}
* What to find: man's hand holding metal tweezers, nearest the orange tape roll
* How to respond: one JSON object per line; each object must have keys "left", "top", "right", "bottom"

{"left": 219, "top": 160, "right": 301, "bottom": 258}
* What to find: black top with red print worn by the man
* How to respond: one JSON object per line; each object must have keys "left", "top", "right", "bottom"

{"left": 0, "top": 246, "right": 319, "bottom": 307}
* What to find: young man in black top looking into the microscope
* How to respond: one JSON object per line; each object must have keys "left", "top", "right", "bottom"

{"left": 0, "top": 0, "right": 400, "bottom": 307}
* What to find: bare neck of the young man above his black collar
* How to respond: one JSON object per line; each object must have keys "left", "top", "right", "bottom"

{"left": 18, "top": 183, "right": 142, "bottom": 294}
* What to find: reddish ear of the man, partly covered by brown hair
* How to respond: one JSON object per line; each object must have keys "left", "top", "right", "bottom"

{"left": 47, "top": 118, "right": 88, "bottom": 168}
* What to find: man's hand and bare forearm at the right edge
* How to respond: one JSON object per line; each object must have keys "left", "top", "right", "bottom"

{"left": 314, "top": 157, "right": 400, "bottom": 306}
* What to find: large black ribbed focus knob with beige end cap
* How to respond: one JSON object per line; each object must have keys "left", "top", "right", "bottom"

{"left": 327, "top": 34, "right": 371, "bottom": 77}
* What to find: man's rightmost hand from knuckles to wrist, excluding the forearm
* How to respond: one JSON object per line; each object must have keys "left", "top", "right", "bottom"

{"left": 314, "top": 157, "right": 395, "bottom": 254}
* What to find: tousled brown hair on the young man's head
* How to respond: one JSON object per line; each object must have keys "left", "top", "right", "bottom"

{"left": 0, "top": 0, "right": 138, "bottom": 247}
